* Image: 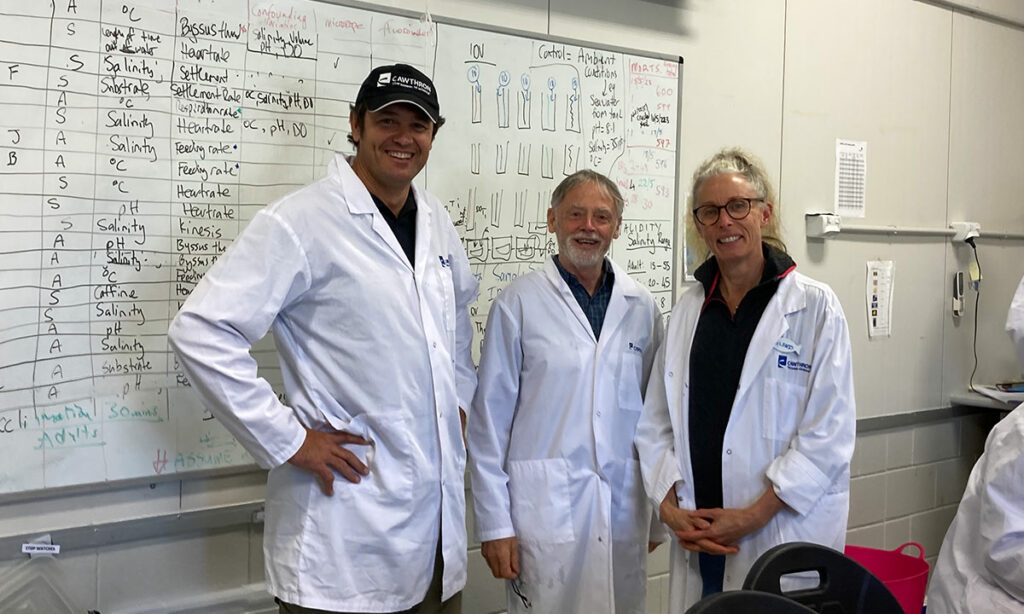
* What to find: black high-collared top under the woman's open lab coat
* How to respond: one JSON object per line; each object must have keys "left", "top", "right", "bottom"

{"left": 689, "top": 244, "right": 796, "bottom": 509}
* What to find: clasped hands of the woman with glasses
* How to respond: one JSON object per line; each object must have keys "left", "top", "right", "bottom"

{"left": 658, "top": 487, "right": 784, "bottom": 555}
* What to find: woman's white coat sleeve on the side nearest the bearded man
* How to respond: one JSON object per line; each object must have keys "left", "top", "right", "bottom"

{"left": 634, "top": 341, "right": 682, "bottom": 511}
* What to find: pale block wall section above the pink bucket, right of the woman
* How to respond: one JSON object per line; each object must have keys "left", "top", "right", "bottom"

{"left": 847, "top": 413, "right": 996, "bottom": 565}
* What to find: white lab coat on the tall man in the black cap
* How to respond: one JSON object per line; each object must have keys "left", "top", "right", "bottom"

{"left": 169, "top": 155, "right": 477, "bottom": 612}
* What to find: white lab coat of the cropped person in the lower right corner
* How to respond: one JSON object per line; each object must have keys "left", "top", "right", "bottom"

{"left": 928, "top": 404, "right": 1024, "bottom": 614}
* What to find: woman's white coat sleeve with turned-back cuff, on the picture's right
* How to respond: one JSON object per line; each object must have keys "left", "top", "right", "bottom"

{"left": 767, "top": 293, "right": 857, "bottom": 515}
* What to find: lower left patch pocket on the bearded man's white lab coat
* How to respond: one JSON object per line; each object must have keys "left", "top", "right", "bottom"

{"left": 509, "top": 458, "right": 575, "bottom": 544}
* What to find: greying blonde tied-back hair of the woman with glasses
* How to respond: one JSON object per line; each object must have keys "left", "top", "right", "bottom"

{"left": 687, "top": 147, "right": 786, "bottom": 258}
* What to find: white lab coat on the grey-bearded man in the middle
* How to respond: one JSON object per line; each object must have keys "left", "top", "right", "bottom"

{"left": 467, "top": 258, "right": 665, "bottom": 614}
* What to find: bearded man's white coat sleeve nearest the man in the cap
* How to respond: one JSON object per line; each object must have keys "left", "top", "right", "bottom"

{"left": 466, "top": 291, "right": 522, "bottom": 541}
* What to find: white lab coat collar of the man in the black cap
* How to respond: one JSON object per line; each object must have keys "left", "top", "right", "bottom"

{"left": 328, "top": 154, "right": 433, "bottom": 271}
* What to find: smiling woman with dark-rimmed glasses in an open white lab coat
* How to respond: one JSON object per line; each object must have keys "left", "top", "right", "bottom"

{"left": 636, "top": 148, "right": 855, "bottom": 612}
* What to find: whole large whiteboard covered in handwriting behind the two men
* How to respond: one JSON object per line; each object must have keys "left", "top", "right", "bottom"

{"left": 0, "top": 0, "right": 679, "bottom": 494}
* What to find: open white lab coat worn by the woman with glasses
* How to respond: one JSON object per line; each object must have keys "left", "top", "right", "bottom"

{"left": 636, "top": 272, "right": 856, "bottom": 612}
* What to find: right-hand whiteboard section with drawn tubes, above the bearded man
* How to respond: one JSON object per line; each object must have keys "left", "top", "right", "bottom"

{"left": 427, "top": 24, "right": 681, "bottom": 348}
